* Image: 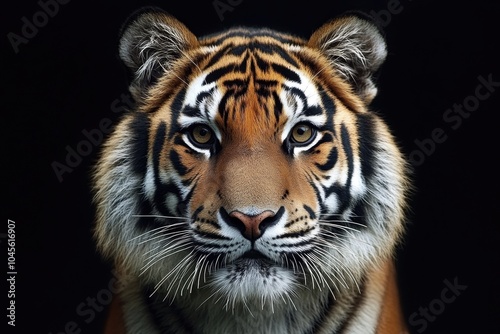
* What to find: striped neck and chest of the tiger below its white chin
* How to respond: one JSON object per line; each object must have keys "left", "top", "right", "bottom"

{"left": 110, "top": 261, "right": 405, "bottom": 334}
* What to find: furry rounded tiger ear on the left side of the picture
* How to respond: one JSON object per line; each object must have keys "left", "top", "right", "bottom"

{"left": 119, "top": 7, "right": 198, "bottom": 100}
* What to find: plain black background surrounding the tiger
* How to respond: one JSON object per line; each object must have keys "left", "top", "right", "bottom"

{"left": 0, "top": 0, "right": 500, "bottom": 334}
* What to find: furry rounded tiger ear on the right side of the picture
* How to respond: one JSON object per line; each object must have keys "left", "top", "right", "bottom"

{"left": 308, "top": 14, "right": 387, "bottom": 104}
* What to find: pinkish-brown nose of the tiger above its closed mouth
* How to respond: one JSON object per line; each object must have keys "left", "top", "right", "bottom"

{"left": 227, "top": 207, "right": 284, "bottom": 241}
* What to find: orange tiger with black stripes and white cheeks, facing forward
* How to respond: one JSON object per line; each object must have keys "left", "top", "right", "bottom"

{"left": 92, "top": 8, "right": 411, "bottom": 334}
